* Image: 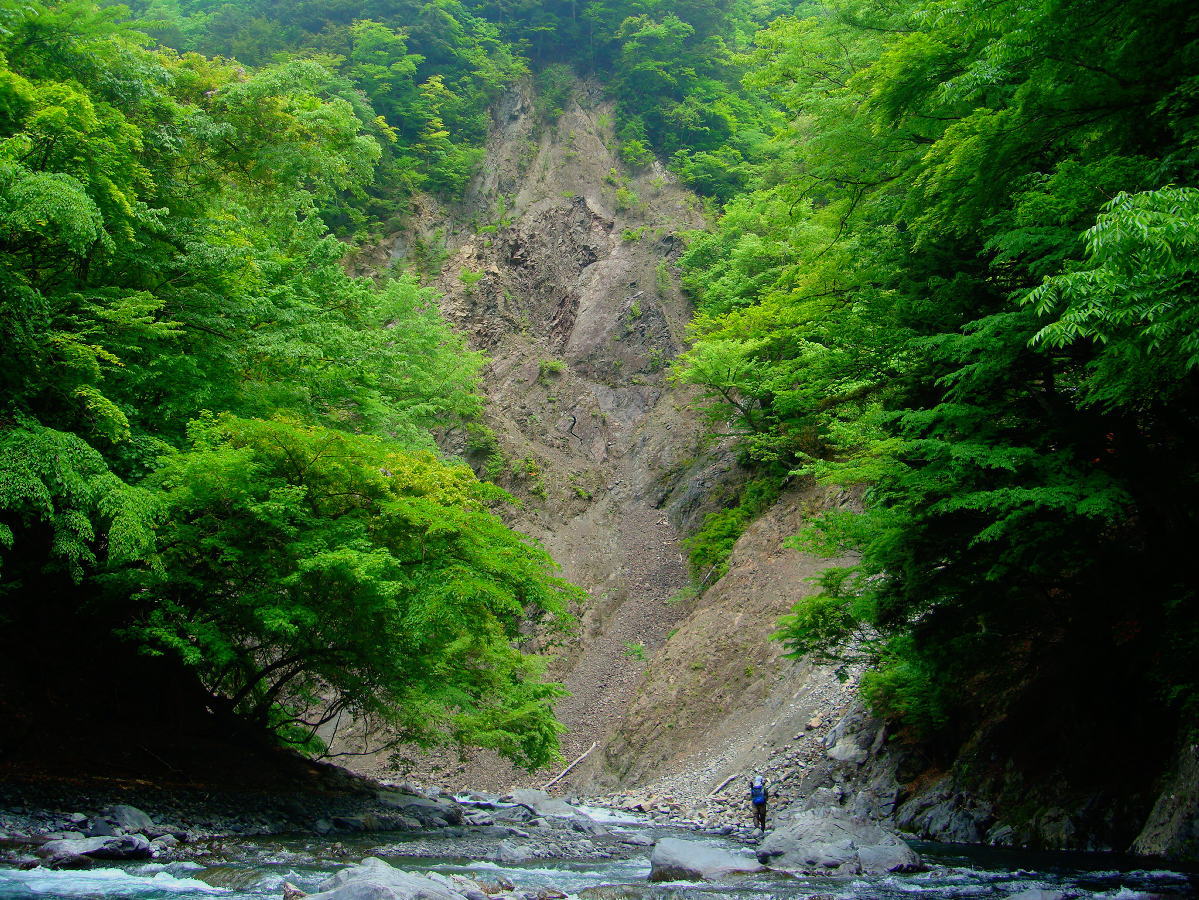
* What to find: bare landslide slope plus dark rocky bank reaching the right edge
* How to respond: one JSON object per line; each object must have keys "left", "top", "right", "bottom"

{"left": 338, "top": 77, "right": 1199, "bottom": 856}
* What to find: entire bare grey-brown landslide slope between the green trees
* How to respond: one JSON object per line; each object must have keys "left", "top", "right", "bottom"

{"left": 342, "top": 84, "right": 849, "bottom": 795}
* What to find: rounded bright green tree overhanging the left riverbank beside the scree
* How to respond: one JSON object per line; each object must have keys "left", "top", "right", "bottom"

{"left": 118, "top": 416, "right": 578, "bottom": 767}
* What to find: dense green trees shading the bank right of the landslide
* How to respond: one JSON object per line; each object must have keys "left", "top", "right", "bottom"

{"left": 677, "top": 0, "right": 1199, "bottom": 736}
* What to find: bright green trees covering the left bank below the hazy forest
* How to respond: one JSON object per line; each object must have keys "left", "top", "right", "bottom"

{"left": 0, "top": 0, "right": 574, "bottom": 765}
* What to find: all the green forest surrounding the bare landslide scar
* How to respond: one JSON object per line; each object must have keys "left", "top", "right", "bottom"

{"left": 0, "top": 0, "right": 1199, "bottom": 795}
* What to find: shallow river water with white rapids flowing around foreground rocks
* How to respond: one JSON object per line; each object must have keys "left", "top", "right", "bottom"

{"left": 0, "top": 810, "right": 1199, "bottom": 900}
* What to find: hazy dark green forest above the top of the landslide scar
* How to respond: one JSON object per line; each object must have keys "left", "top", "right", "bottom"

{"left": 124, "top": 0, "right": 791, "bottom": 203}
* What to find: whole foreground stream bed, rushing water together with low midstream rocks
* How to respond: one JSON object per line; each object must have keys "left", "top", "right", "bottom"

{"left": 0, "top": 796, "right": 1194, "bottom": 900}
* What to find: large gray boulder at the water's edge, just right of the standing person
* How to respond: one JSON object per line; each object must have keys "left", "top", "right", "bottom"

{"left": 758, "top": 807, "right": 923, "bottom": 875}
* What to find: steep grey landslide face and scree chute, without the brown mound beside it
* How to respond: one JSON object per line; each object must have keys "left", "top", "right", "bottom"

{"left": 338, "top": 85, "right": 739, "bottom": 787}
